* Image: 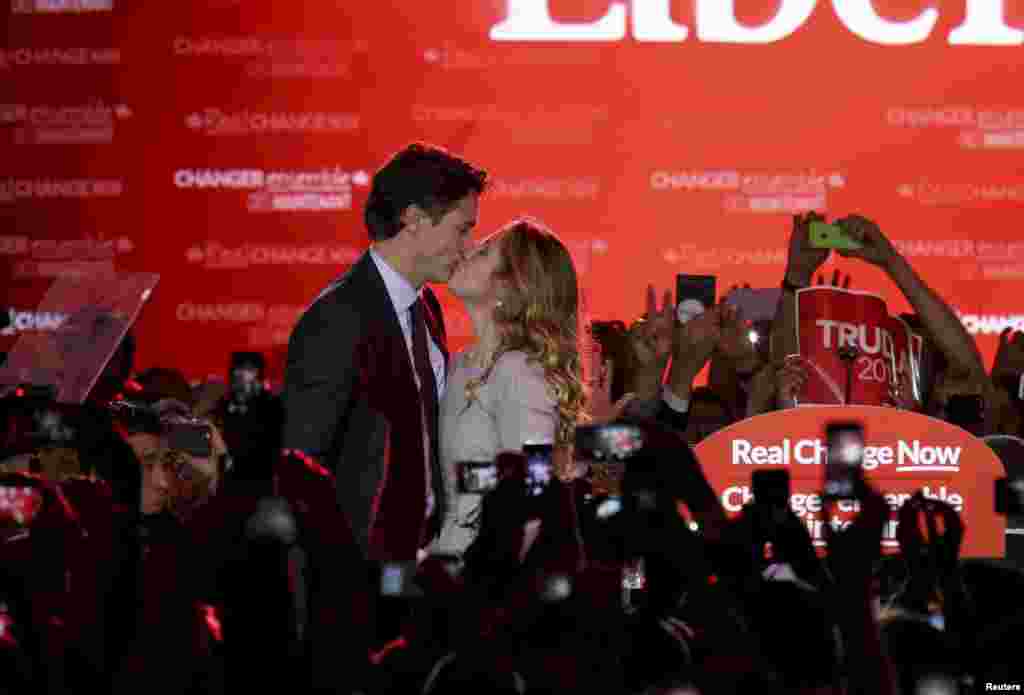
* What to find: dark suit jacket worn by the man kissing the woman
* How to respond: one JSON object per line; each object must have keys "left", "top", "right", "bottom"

{"left": 283, "top": 252, "right": 449, "bottom": 560}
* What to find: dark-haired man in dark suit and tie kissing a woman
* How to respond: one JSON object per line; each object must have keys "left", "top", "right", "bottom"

{"left": 283, "top": 143, "right": 486, "bottom": 562}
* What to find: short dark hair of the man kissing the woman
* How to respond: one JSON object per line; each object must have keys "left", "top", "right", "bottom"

{"left": 364, "top": 142, "right": 487, "bottom": 242}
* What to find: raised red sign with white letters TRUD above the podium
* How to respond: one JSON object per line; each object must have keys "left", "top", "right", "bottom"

{"left": 797, "top": 286, "right": 915, "bottom": 405}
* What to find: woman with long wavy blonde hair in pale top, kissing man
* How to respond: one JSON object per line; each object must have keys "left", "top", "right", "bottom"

{"left": 436, "top": 219, "right": 586, "bottom": 555}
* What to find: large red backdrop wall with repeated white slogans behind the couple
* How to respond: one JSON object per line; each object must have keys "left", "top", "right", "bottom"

{"left": 6, "top": 0, "right": 1024, "bottom": 386}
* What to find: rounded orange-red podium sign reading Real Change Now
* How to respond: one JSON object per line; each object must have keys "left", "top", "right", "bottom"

{"left": 695, "top": 406, "right": 1007, "bottom": 558}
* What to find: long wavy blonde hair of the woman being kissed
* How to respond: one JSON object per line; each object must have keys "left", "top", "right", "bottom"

{"left": 466, "top": 218, "right": 587, "bottom": 445}
